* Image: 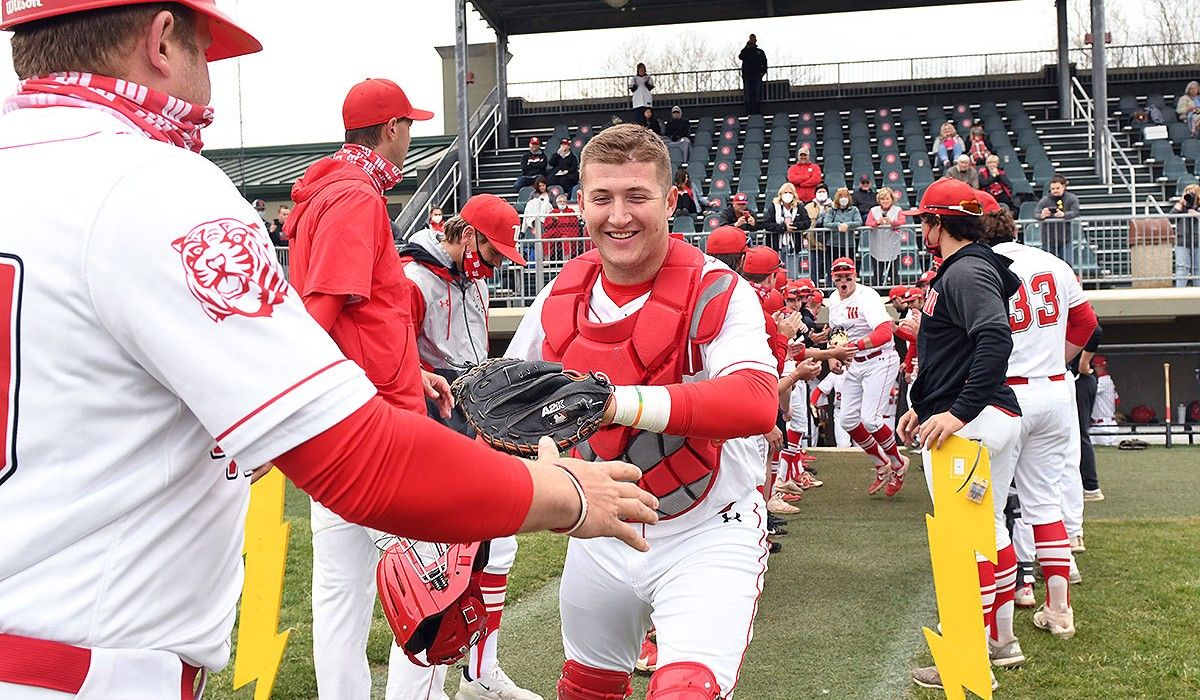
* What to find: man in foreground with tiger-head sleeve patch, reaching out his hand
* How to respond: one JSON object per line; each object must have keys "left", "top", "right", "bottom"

{"left": 0, "top": 0, "right": 656, "bottom": 700}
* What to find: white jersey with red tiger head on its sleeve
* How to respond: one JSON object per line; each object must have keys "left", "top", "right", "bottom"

{"left": 0, "top": 107, "right": 374, "bottom": 669}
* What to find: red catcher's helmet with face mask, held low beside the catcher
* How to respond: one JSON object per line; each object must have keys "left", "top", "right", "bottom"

{"left": 376, "top": 537, "right": 487, "bottom": 666}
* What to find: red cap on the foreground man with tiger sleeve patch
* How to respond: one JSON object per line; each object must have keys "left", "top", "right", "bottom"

{"left": 0, "top": 0, "right": 263, "bottom": 61}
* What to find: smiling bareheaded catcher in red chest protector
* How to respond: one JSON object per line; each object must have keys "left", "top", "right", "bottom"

{"left": 508, "top": 125, "right": 779, "bottom": 700}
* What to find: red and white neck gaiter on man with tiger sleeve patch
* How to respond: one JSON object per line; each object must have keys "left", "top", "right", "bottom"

{"left": 4, "top": 72, "right": 212, "bottom": 152}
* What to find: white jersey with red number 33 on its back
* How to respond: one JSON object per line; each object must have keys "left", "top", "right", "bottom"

{"left": 992, "top": 243, "right": 1087, "bottom": 378}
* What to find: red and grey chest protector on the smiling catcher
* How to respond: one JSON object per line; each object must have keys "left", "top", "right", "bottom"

{"left": 541, "top": 240, "right": 737, "bottom": 519}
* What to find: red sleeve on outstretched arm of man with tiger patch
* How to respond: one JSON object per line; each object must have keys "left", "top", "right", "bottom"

{"left": 275, "top": 396, "right": 533, "bottom": 543}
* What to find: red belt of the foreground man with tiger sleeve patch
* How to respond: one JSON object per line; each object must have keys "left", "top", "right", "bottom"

{"left": 0, "top": 634, "right": 200, "bottom": 699}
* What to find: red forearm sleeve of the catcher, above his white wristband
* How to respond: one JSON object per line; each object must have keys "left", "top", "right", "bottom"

{"left": 662, "top": 370, "right": 779, "bottom": 439}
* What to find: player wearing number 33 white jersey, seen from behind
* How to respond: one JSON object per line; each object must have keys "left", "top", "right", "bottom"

{"left": 976, "top": 192, "right": 1097, "bottom": 666}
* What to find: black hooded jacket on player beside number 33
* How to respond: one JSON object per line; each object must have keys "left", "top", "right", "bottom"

{"left": 911, "top": 244, "right": 1021, "bottom": 423}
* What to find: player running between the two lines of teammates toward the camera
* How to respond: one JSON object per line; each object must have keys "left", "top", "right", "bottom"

{"left": 829, "top": 258, "right": 908, "bottom": 497}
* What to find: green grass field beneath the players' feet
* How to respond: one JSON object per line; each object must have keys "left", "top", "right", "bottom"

{"left": 208, "top": 448, "right": 1200, "bottom": 700}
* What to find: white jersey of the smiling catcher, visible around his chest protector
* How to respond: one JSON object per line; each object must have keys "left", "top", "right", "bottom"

{"left": 505, "top": 258, "right": 778, "bottom": 537}
